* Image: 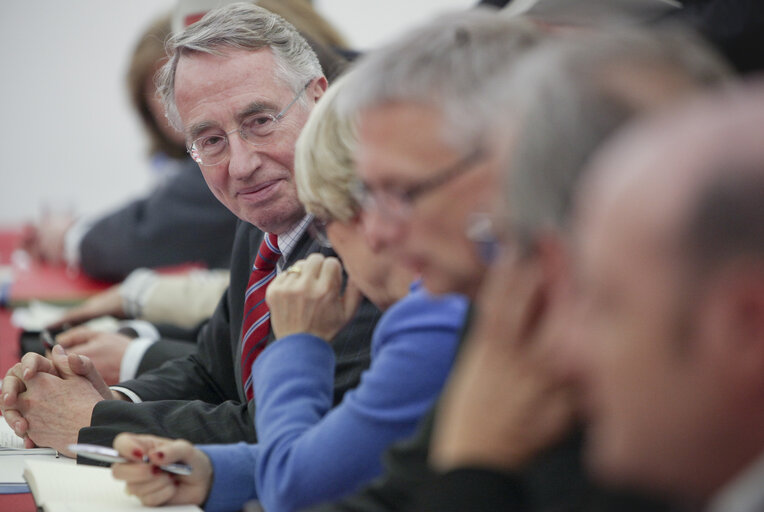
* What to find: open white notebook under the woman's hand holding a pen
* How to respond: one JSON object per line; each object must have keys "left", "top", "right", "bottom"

{"left": 24, "top": 459, "right": 201, "bottom": 512}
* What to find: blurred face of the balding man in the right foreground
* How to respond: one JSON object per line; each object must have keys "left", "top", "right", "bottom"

{"left": 571, "top": 174, "right": 725, "bottom": 498}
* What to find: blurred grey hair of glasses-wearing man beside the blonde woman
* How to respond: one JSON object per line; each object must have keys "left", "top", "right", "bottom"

{"left": 339, "top": 9, "right": 541, "bottom": 150}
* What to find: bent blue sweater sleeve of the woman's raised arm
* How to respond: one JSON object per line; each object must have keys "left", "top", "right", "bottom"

{"left": 251, "top": 290, "right": 467, "bottom": 512}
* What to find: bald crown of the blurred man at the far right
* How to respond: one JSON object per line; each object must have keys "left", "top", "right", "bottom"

{"left": 587, "top": 85, "right": 764, "bottom": 274}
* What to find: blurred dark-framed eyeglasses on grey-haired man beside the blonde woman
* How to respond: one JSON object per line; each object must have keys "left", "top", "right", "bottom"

{"left": 353, "top": 148, "right": 486, "bottom": 220}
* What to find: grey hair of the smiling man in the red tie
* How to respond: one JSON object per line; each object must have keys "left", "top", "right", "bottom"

{"left": 157, "top": 2, "right": 323, "bottom": 130}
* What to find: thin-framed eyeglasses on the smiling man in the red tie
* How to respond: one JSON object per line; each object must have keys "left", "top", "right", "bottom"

{"left": 188, "top": 82, "right": 310, "bottom": 166}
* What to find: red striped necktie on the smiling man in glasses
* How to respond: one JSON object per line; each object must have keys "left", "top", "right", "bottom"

{"left": 241, "top": 233, "right": 281, "bottom": 400}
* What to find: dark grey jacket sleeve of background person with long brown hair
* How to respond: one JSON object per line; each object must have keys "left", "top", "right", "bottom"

{"left": 80, "top": 158, "right": 237, "bottom": 281}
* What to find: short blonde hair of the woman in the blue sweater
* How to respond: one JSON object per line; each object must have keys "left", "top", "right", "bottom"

{"left": 294, "top": 72, "right": 361, "bottom": 222}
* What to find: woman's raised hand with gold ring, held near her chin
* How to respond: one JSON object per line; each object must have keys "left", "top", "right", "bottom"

{"left": 265, "top": 254, "right": 362, "bottom": 341}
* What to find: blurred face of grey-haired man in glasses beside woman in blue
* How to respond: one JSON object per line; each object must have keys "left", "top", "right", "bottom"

{"left": 357, "top": 103, "right": 498, "bottom": 295}
